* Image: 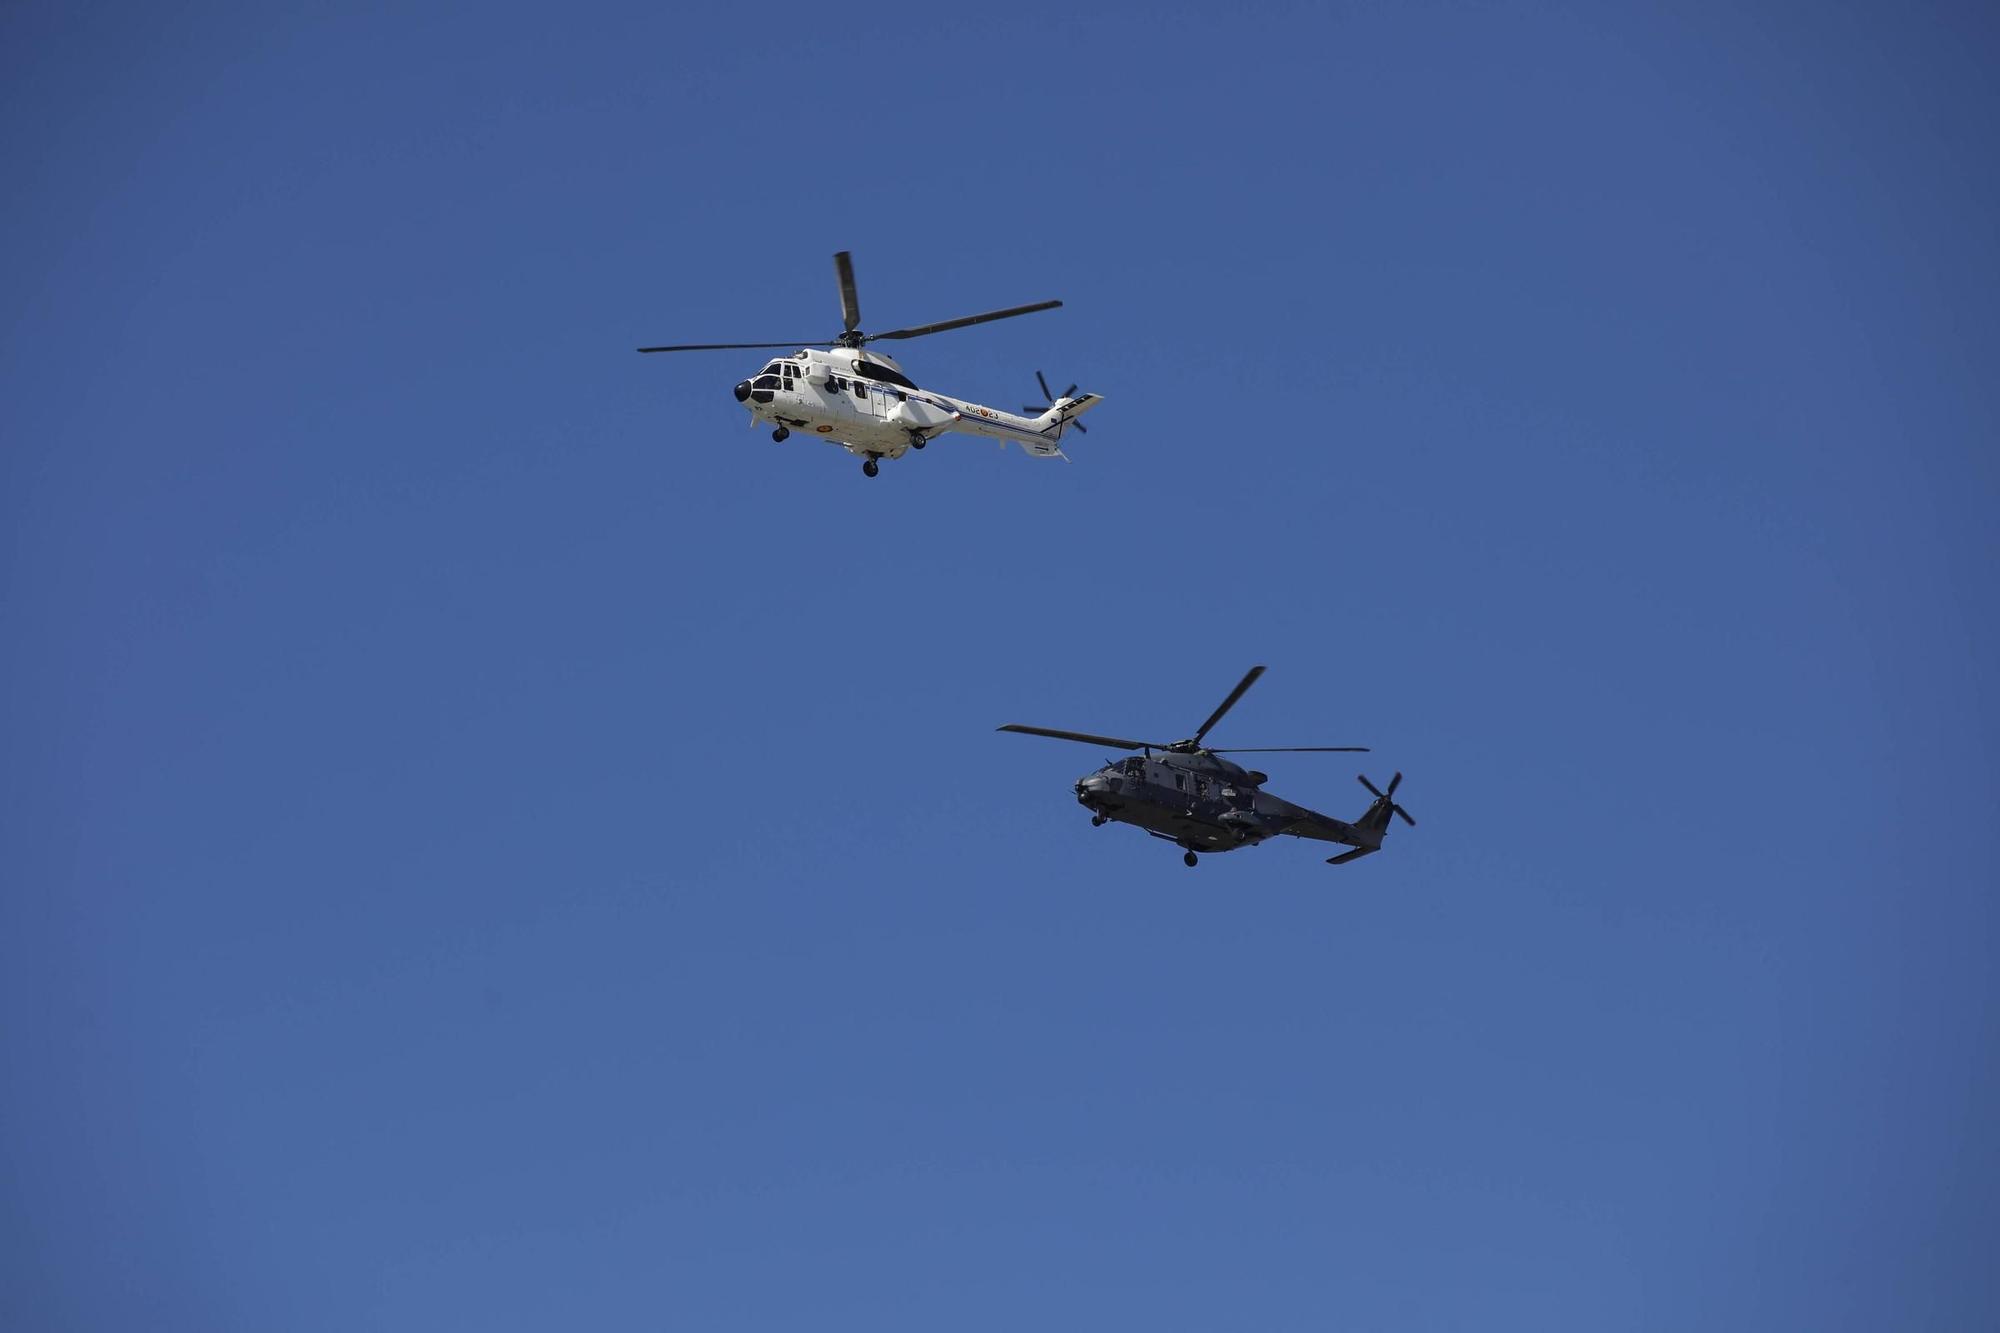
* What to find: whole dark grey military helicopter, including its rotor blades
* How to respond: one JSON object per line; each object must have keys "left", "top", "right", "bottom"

{"left": 1000, "top": 667, "right": 1416, "bottom": 865}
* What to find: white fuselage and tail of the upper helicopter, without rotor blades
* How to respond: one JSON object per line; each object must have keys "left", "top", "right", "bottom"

{"left": 736, "top": 346, "right": 1102, "bottom": 460}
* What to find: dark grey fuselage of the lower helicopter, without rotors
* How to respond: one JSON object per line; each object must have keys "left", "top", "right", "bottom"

{"left": 1076, "top": 751, "right": 1382, "bottom": 853}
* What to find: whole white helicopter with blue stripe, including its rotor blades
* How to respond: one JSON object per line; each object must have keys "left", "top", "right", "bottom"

{"left": 640, "top": 250, "right": 1104, "bottom": 476}
